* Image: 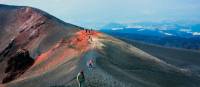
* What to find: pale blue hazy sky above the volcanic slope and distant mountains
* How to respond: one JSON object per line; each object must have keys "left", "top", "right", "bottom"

{"left": 0, "top": 0, "right": 200, "bottom": 28}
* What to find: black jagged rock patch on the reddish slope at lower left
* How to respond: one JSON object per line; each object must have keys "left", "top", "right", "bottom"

{"left": 2, "top": 49, "right": 34, "bottom": 83}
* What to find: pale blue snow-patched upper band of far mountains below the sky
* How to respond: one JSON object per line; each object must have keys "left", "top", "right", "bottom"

{"left": 101, "top": 23, "right": 200, "bottom": 38}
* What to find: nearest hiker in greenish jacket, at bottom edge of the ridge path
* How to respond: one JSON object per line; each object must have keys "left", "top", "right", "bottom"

{"left": 76, "top": 70, "right": 85, "bottom": 87}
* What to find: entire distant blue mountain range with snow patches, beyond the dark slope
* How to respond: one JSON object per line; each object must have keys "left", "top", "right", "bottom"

{"left": 100, "top": 23, "right": 200, "bottom": 50}
